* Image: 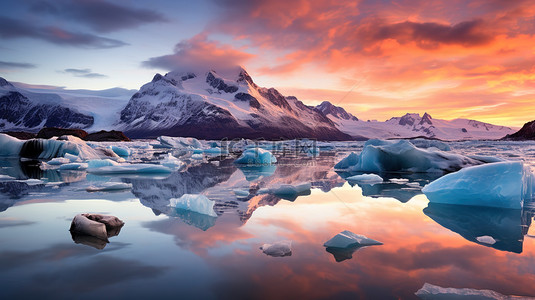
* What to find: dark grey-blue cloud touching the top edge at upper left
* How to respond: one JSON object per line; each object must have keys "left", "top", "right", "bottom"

{"left": 31, "top": 0, "right": 167, "bottom": 32}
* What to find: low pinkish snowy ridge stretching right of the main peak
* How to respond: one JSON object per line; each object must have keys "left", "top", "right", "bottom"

{"left": 316, "top": 102, "right": 515, "bottom": 140}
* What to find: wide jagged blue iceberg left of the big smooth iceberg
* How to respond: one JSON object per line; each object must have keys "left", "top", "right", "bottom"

{"left": 334, "top": 140, "right": 485, "bottom": 173}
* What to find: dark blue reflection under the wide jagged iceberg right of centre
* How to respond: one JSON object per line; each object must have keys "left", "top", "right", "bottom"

{"left": 337, "top": 171, "right": 442, "bottom": 203}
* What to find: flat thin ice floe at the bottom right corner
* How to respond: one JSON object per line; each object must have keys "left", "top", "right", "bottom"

{"left": 415, "top": 283, "right": 533, "bottom": 300}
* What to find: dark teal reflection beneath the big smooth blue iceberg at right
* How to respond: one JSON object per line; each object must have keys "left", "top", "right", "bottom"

{"left": 423, "top": 203, "right": 533, "bottom": 253}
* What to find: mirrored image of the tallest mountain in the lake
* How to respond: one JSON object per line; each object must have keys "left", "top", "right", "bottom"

{"left": 127, "top": 157, "right": 344, "bottom": 226}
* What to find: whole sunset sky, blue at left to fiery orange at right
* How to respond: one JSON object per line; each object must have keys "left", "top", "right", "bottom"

{"left": 0, "top": 0, "right": 535, "bottom": 126}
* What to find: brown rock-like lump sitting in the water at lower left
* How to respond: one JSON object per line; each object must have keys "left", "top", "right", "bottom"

{"left": 70, "top": 214, "right": 124, "bottom": 241}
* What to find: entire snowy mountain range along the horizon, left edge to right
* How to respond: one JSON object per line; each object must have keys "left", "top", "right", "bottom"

{"left": 0, "top": 67, "right": 516, "bottom": 140}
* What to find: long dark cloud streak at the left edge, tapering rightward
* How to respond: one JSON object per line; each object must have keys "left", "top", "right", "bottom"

{"left": 0, "top": 16, "right": 127, "bottom": 49}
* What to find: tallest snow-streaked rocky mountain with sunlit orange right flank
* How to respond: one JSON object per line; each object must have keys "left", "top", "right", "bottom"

{"left": 116, "top": 67, "right": 351, "bottom": 140}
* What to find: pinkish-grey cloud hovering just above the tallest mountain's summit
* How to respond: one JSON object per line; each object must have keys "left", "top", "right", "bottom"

{"left": 142, "top": 34, "right": 253, "bottom": 72}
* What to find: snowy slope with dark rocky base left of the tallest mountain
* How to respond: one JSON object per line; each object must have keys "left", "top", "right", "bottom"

{"left": 0, "top": 77, "right": 134, "bottom": 131}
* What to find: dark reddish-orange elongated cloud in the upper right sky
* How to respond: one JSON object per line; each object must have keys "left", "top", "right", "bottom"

{"left": 358, "top": 20, "right": 493, "bottom": 49}
